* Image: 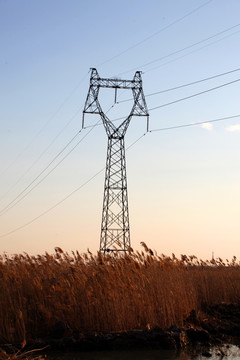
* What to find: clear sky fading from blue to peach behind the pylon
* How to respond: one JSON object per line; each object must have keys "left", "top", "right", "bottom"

{"left": 0, "top": 0, "right": 240, "bottom": 258}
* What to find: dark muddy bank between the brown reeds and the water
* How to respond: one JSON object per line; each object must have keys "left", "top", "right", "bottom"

{"left": 0, "top": 304, "right": 240, "bottom": 357}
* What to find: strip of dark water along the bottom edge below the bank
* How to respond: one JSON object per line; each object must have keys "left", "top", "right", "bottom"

{"left": 47, "top": 345, "right": 240, "bottom": 360}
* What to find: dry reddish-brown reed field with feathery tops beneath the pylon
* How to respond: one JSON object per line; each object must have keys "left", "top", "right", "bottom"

{"left": 0, "top": 243, "right": 240, "bottom": 344}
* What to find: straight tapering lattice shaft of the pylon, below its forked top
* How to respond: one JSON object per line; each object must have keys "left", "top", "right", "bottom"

{"left": 100, "top": 136, "right": 130, "bottom": 253}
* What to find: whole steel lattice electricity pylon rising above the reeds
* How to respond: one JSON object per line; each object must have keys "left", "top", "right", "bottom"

{"left": 82, "top": 68, "right": 149, "bottom": 253}
